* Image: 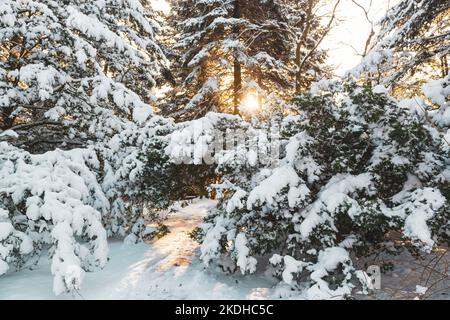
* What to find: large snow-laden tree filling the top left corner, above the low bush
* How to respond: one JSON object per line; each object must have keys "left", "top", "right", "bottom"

{"left": 0, "top": 0, "right": 164, "bottom": 152}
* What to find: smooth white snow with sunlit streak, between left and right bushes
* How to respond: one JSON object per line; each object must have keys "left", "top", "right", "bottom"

{"left": 0, "top": 200, "right": 274, "bottom": 299}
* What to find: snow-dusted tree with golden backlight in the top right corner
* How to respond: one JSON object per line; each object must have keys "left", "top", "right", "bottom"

{"left": 354, "top": 0, "right": 450, "bottom": 97}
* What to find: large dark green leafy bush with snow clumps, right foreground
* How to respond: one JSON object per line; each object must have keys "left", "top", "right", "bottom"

{"left": 187, "top": 82, "right": 450, "bottom": 299}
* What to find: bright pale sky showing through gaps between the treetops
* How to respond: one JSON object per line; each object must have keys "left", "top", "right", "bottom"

{"left": 152, "top": 0, "right": 400, "bottom": 75}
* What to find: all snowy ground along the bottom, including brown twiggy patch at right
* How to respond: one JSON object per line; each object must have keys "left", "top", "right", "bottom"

{"left": 0, "top": 199, "right": 450, "bottom": 299}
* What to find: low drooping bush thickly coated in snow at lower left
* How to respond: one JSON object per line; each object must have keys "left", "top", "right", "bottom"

{"left": 0, "top": 142, "right": 109, "bottom": 294}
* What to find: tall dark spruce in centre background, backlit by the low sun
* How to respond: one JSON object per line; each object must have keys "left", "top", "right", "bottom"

{"left": 163, "top": 0, "right": 325, "bottom": 119}
